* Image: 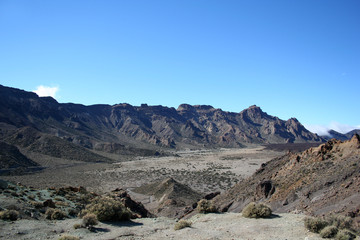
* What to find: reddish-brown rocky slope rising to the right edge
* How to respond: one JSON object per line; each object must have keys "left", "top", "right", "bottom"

{"left": 215, "top": 135, "right": 360, "bottom": 230}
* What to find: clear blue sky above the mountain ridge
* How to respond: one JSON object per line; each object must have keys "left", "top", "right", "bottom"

{"left": 0, "top": 0, "right": 360, "bottom": 132}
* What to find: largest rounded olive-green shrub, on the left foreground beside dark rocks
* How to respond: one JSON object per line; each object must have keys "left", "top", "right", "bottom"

{"left": 81, "top": 197, "right": 131, "bottom": 221}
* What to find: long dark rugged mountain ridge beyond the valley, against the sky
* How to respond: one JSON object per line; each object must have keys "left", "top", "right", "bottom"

{"left": 0, "top": 85, "right": 323, "bottom": 156}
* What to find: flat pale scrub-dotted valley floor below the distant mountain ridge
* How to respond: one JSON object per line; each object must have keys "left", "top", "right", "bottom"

{"left": 2, "top": 147, "right": 284, "bottom": 193}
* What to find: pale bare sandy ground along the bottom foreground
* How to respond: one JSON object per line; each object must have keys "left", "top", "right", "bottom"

{"left": 0, "top": 213, "right": 330, "bottom": 240}
